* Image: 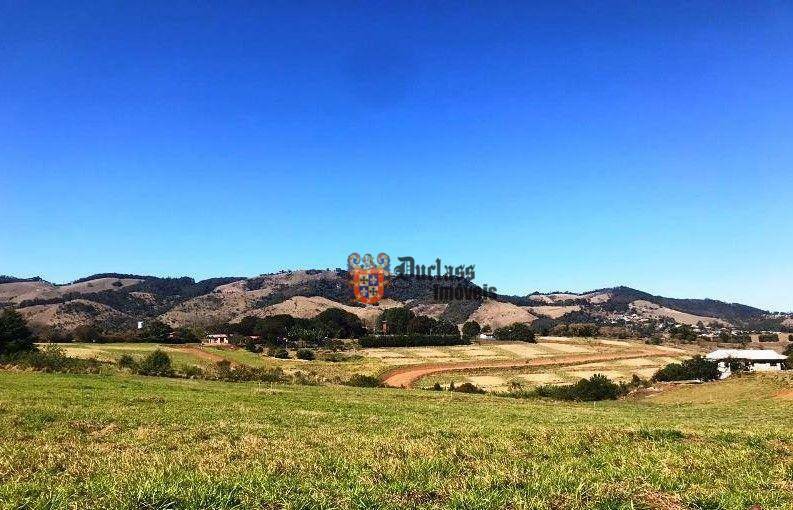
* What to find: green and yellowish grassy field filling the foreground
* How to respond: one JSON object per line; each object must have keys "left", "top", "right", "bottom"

{"left": 0, "top": 372, "right": 793, "bottom": 510}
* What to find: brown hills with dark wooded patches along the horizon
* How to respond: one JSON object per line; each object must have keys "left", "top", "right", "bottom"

{"left": 0, "top": 269, "right": 793, "bottom": 331}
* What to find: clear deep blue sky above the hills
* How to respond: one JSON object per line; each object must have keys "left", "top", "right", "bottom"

{"left": 0, "top": 1, "right": 793, "bottom": 311}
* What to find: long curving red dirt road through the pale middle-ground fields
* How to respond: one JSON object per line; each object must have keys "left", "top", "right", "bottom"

{"left": 380, "top": 351, "right": 669, "bottom": 388}
